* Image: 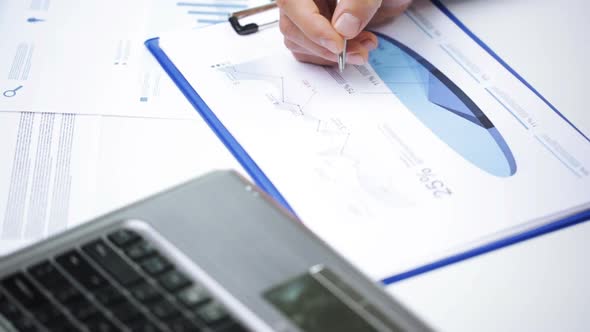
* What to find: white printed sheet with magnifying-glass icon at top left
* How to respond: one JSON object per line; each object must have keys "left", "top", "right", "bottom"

{"left": 0, "top": 0, "right": 268, "bottom": 119}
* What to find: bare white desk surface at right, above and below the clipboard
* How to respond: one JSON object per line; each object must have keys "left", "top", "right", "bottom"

{"left": 389, "top": 0, "right": 590, "bottom": 331}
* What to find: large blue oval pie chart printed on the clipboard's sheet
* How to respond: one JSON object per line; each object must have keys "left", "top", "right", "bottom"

{"left": 369, "top": 34, "right": 516, "bottom": 177}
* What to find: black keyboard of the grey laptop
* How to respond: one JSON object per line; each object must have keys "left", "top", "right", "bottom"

{"left": 0, "top": 230, "right": 246, "bottom": 332}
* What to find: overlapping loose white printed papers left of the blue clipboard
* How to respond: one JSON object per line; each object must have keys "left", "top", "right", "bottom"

{"left": 0, "top": 0, "right": 272, "bottom": 254}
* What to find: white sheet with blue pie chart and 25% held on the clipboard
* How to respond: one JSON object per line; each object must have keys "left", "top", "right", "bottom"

{"left": 159, "top": 0, "right": 590, "bottom": 279}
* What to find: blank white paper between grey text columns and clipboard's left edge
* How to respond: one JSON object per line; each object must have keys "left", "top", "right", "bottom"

{"left": 96, "top": 115, "right": 241, "bottom": 214}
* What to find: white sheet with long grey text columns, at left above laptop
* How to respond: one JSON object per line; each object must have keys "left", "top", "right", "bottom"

{"left": 0, "top": 113, "right": 100, "bottom": 254}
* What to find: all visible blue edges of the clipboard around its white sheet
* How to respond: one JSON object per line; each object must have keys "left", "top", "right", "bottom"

{"left": 145, "top": 0, "right": 590, "bottom": 285}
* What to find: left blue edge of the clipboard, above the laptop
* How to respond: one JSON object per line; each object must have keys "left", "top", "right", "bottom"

{"left": 145, "top": 38, "right": 296, "bottom": 216}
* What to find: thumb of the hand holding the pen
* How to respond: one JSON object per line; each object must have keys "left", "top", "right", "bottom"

{"left": 332, "top": 0, "right": 381, "bottom": 39}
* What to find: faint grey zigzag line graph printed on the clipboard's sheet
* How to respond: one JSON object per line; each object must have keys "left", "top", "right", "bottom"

{"left": 217, "top": 58, "right": 412, "bottom": 213}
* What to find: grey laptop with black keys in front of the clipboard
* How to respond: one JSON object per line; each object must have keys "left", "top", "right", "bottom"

{"left": 0, "top": 171, "right": 430, "bottom": 332}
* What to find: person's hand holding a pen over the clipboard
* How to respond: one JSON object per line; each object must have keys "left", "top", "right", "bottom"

{"left": 277, "top": 0, "right": 412, "bottom": 65}
